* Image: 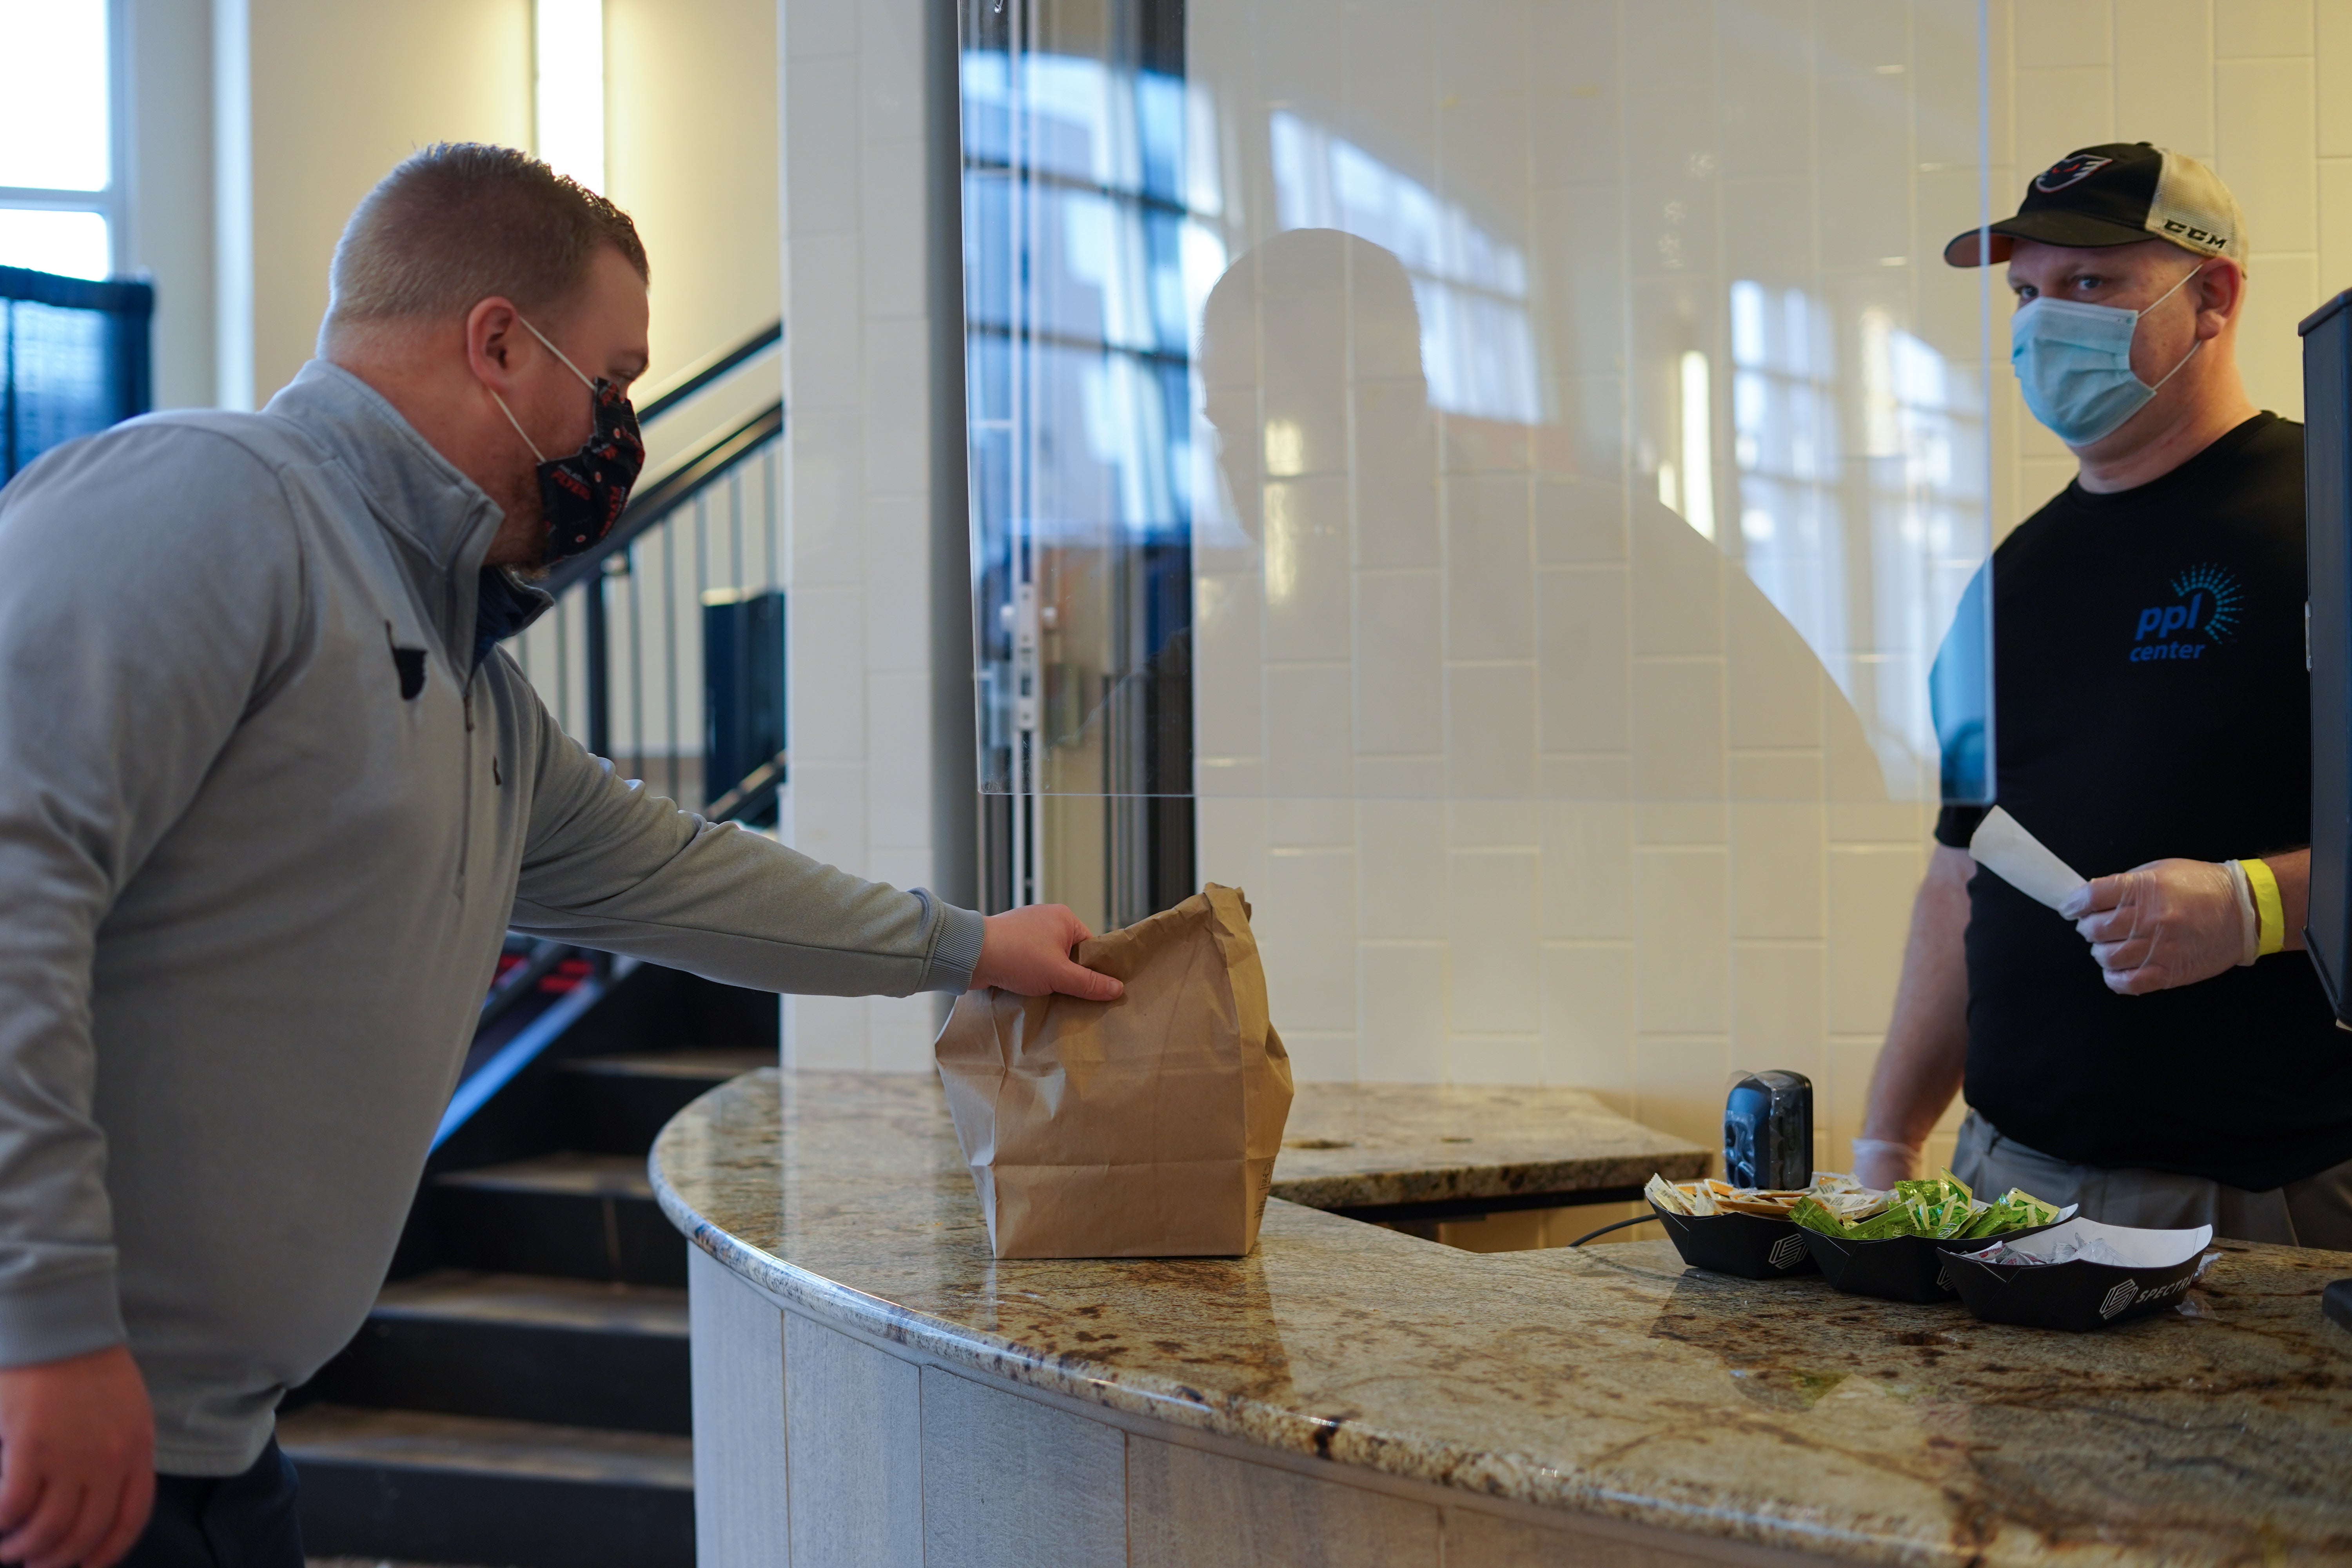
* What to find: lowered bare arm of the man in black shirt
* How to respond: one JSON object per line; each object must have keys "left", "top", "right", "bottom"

{"left": 1853, "top": 844, "right": 1976, "bottom": 1187}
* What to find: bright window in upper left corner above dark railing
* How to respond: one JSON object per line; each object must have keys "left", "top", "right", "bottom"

{"left": 0, "top": 0, "right": 122, "bottom": 278}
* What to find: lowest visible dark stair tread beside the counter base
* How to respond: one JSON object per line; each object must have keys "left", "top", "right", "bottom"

{"left": 278, "top": 1403, "right": 694, "bottom": 1490}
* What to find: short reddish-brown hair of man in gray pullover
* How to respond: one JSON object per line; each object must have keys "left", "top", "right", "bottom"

{"left": 322, "top": 141, "right": 652, "bottom": 336}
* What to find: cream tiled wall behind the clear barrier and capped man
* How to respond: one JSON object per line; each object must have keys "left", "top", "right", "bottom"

{"left": 1171, "top": 0, "right": 2352, "bottom": 1161}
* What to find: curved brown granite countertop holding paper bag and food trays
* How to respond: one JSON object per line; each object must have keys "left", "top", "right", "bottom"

{"left": 654, "top": 1072, "right": 2352, "bottom": 1563}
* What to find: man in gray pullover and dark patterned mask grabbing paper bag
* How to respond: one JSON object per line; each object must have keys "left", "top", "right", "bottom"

{"left": 0, "top": 146, "right": 1120, "bottom": 1568}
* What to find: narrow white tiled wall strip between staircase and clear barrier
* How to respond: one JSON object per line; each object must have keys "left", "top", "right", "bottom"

{"left": 781, "top": 0, "right": 938, "bottom": 1072}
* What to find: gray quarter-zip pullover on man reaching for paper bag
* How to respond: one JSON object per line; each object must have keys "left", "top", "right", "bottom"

{"left": 0, "top": 362, "right": 981, "bottom": 1476}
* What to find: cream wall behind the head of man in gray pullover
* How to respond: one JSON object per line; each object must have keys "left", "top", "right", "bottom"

{"left": 207, "top": 0, "right": 779, "bottom": 407}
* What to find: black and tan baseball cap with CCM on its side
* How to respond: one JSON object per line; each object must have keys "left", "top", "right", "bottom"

{"left": 1943, "top": 141, "right": 2246, "bottom": 266}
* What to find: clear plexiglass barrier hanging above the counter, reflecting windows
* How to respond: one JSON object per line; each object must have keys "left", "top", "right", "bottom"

{"left": 962, "top": 0, "right": 2006, "bottom": 921}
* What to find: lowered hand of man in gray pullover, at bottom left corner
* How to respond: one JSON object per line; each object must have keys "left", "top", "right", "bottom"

{"left": 0, "top": 1345, "right": 155, "bottom": 1568}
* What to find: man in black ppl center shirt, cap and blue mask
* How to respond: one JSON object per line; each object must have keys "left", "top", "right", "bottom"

{"left": 1856, "top": 143, "right": 2352, "bottom": 1248}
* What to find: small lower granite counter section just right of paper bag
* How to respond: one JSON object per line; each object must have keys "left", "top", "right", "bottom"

{"left": 1275, "top": 1084, "right": 1710, "bottom": 1208}
